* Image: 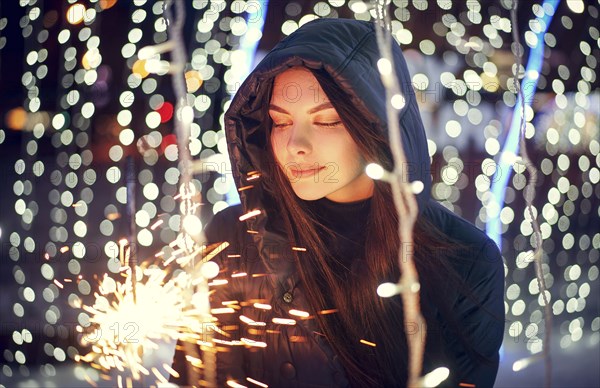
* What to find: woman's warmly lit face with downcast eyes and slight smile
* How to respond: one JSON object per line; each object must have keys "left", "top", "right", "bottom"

{"left": 269, "top": 67, "right": 374, "bottom": 202}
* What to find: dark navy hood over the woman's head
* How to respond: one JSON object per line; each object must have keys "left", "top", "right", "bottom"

{"left": 225, "top": 19, "right": 431, "bottom": 235}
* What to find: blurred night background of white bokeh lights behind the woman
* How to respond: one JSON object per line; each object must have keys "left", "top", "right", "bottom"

{"left": 0, "top": 0, "right": 600, "bottom": 387}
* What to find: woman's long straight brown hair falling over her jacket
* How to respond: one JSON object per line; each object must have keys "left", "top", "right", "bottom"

{"left": 264, "top": 69, "right": 502, "bottom": 387}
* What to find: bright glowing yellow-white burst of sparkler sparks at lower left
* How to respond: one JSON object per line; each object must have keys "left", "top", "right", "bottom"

{"left": 80, "top": 266, "right": 212, "bottom": 380}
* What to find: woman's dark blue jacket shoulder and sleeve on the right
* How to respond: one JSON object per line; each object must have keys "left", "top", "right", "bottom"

{"left": 423, "top": 200, "right": 505, "bottom": 387}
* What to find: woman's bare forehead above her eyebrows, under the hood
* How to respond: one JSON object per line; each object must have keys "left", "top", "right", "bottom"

{"left": 271, "top": 67, "right": 328, "bottom": 105}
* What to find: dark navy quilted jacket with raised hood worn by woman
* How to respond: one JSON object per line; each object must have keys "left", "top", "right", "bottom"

{"left": 172, "top": 19, "right": 505, "bottom": 388}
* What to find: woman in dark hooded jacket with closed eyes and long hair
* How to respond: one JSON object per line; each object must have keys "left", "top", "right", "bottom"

{"left": 174, "top": 19, "right": 504, "bottom": 387}
